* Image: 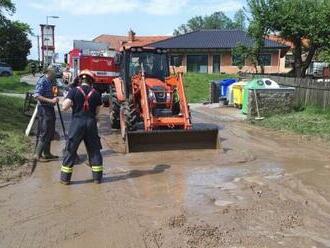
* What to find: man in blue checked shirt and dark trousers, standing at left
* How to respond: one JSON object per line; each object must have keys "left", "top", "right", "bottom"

{"left": 34, "top": 67, "right": 58, "bottom": 161}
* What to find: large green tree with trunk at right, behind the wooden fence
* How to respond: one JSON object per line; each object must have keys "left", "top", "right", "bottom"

{"left": 248, "top": 0, "right": 330, "bottom": 77}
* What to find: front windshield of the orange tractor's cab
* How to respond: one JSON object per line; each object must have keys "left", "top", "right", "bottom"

{"left": 129, "top": 52, "right": 169, "bottom": 79}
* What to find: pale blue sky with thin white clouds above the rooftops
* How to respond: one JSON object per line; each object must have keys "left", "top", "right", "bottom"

{"left": 12, "top": 0, "right": 245, "bottom": 59}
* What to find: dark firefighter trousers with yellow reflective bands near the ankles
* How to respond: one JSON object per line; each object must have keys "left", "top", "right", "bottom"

{"left": 61, "top": 114, "right": 103, "bottom": 182}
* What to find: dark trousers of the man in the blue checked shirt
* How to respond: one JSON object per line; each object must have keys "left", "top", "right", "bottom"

{"left": 37, "top": 105, "right": 56, "bottom": 156}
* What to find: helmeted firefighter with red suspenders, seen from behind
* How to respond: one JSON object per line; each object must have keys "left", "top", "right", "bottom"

{"left": 61, "top": 70, "right": 103, "bottom": 185}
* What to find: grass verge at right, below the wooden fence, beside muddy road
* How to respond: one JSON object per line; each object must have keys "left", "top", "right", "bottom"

{"left": 254, "top": 106, "right": 330, "bottom": 141}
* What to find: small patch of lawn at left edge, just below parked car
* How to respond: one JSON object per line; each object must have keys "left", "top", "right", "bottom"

{"left": 0, "top": 72, "right": 33, "bottom": 93}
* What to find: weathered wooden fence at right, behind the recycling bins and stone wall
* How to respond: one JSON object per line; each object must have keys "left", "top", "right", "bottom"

{"left": 244, "top": 75, "right": 330, "bottom": 109}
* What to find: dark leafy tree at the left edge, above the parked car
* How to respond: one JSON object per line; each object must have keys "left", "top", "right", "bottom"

{"left": 0, "top": 0, "right": 32, "bottom": 69}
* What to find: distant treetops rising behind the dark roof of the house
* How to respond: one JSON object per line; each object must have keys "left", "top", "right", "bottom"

{"left": 173, "top": 10, "right": 246, "bottom": 35}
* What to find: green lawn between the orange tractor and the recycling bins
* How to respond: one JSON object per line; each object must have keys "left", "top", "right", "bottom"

{"left": 183, "top": 73, "right": 238, "bottom": 103}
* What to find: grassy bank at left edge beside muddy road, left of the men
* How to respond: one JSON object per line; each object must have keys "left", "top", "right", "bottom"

{"left": 0, "top": 95, "right": 31, "bottom": 172}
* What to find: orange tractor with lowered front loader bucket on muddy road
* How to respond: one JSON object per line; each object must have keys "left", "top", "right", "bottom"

{"left": 110, "top": 47, "right": 218, "bottom": 152}
